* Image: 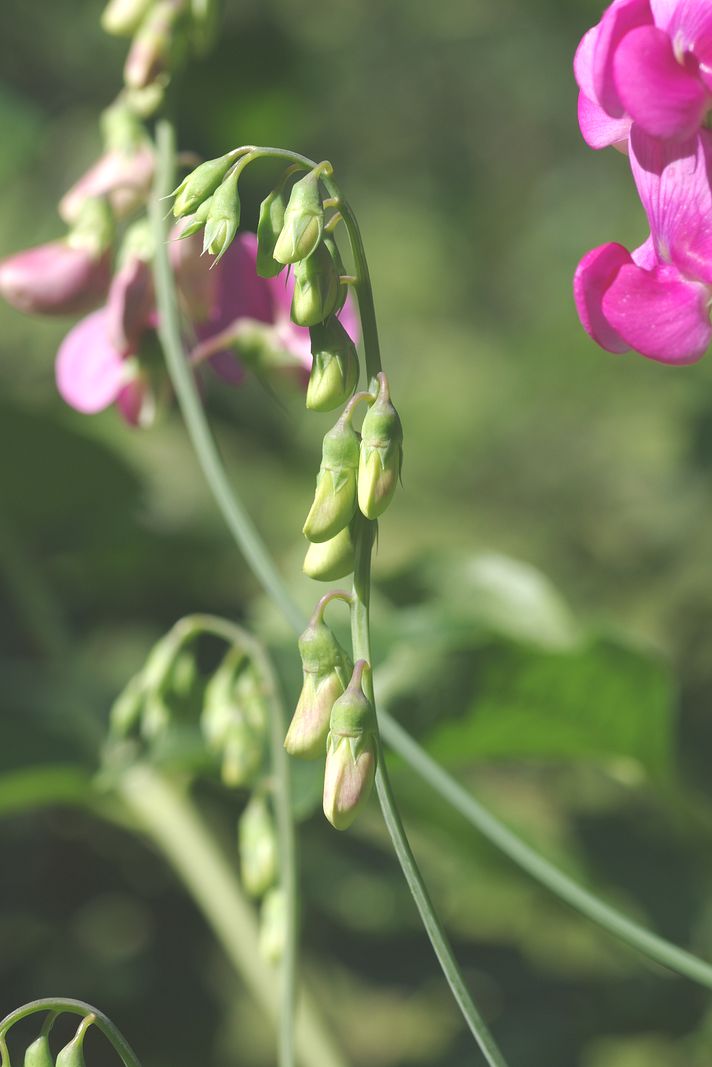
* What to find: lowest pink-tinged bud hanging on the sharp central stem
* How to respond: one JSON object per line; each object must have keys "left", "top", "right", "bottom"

{"left": 323, "top": 659, "right": 377, "bottom": 830}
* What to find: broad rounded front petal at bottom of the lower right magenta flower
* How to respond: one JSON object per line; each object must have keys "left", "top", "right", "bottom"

{"left": 602, "top": 264, "right": 712, "bottom": 364}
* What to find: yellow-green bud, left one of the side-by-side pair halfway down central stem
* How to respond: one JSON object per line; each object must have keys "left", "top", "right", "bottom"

{"left": 303, "top": 411, "right": 359, "bottom": 541}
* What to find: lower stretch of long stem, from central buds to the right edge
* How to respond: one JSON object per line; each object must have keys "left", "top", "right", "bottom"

{"left": 379, "top": 710, "right": 712, "bottom": 989}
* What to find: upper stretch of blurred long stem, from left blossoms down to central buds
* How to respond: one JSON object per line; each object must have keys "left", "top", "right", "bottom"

{"left": 151, "top": 120, "right": 302, "bottom": 627}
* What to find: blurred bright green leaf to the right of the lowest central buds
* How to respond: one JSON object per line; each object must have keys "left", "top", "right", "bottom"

{"left": 427, "top": 637, "right": 675, "bottom": 776}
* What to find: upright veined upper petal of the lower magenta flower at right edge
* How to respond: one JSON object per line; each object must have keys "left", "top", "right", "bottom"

{"left": 630, "top": 126, "right": 712, "bottom": 284}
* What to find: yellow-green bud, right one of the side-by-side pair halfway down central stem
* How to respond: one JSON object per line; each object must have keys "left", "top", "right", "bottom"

{"left": 359, "top": 373, "right": 402, "bottom": 519}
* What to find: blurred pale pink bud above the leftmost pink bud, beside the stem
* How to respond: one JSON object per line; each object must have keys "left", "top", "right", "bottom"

{"left": 59, "top": 144, "right": 155, "bottom": 225}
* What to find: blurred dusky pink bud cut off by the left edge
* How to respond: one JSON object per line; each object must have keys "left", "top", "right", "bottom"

{"left": 0, "top": 240, "right": 111, "bottom": 315}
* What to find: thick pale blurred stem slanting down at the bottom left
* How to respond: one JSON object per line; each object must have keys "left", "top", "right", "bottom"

{"left": 117, "top": 764, "right": 345, "bottom": 1067}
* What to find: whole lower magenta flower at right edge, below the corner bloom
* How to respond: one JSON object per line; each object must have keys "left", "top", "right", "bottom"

{"left": 573, "top": 127, "right": 712, "bottom": 364}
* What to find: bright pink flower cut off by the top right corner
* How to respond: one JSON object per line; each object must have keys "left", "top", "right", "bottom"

{"left": 574, "top": 0, "right": 712, "bottom": 148}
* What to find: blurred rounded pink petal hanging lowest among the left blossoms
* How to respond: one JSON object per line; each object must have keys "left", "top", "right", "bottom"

{"left": 54, "top": 307, "right": 126, "bottom": 415}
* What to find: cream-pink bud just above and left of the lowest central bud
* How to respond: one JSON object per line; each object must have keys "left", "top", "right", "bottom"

{"left": 284, "top": 603, "right": 353, "bottom": 760}
